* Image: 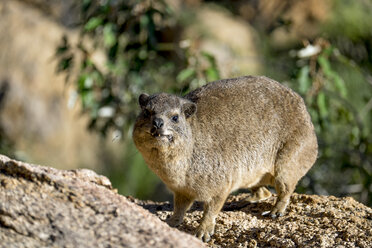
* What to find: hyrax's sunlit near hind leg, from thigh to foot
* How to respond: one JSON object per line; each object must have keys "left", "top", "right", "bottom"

{"left": 263, "top": 135, "right": 317, "bottom": 218}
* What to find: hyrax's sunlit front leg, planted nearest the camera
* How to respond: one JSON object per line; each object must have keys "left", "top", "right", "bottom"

{"left": 196, "top": 196, "right": 227, "bottom": 242}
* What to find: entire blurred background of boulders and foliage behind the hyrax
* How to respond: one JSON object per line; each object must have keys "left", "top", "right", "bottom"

{"left": 0, "top": 0, "right": 372, "bottom": 206}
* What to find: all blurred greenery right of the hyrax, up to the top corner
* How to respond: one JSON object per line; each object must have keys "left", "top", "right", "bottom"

{"left": 261, "top": 0, "right": 372, "bottom": 205}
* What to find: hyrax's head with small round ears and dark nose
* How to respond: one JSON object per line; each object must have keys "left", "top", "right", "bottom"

{"left": 133, "top": 93, "right": 196, "bottom": 148}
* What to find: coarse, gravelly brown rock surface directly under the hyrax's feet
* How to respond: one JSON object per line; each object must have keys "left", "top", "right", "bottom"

{"left": 132, "top": 194, "right": 372, "bottom": 248}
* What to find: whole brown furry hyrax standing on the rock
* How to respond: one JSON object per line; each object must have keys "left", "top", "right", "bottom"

{"left": 133, "top": 76, "right": 318, "bottom": 241}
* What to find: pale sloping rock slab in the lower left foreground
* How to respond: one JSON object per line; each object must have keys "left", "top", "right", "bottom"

{"left": 0, "top": 155, "right": 204, "bottom": 247}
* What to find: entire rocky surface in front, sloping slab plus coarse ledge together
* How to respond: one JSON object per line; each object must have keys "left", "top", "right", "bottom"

{"left": 0, "top": 155, "right": 372, "bottom": 247}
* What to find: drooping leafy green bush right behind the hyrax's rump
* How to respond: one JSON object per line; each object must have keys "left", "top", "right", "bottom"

{"left": 292, "top": 39, "right": 372, "bottom": 203}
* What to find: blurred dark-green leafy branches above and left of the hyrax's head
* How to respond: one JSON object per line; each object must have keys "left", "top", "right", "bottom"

{"left": 56, "top": 0, "right": 219, "bottom": 198}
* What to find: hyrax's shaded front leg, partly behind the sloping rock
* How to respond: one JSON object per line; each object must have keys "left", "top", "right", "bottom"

{"left": 167, "top": 192, "right": 194, "bottom": 227}
